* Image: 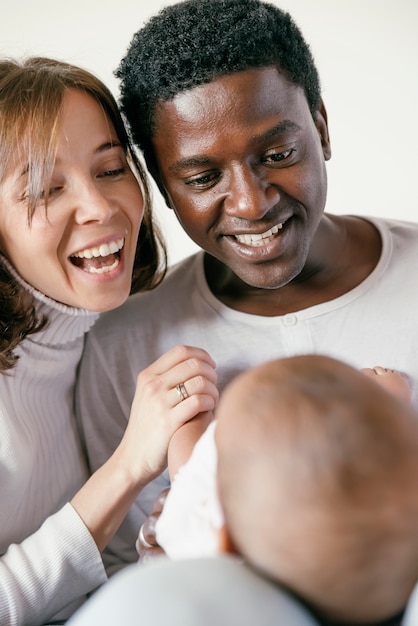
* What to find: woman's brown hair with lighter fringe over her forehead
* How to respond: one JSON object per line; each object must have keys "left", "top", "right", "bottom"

{"left": 0, "top": 57, "right": 166, "bottom": 371}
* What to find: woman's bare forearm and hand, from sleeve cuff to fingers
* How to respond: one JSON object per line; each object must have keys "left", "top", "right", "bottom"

{"left": 71, "top": 346, "right": 218, "bottom": 551}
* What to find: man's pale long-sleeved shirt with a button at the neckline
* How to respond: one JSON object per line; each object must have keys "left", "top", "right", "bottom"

{"left": 78, "top": 218, "right": 418, "bottom": 571}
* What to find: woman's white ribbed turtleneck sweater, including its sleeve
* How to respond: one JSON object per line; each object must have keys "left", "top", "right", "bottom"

{"left": 0, "top": 260, "right": 106, "bottom": 626}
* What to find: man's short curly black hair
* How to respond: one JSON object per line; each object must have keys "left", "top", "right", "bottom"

{"left": 115, "top": 0, "right": 321, "bottom": 161}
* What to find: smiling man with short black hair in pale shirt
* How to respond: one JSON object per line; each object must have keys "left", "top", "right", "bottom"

{"left": 78, "top": 0, "right": 418, "bottom": 571}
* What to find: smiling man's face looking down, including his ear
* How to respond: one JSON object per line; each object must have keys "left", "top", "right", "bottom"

{"left": 153, "top": 67, "right": 330, "bottom": 289}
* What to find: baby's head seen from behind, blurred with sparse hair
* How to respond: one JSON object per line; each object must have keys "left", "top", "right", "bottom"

{"left": 216, "top": 356, "right": 418, "bottom": 624}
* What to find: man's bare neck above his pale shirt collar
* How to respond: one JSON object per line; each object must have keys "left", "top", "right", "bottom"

{"left": 205, "top": 216, "right": 381, "bottom": 316}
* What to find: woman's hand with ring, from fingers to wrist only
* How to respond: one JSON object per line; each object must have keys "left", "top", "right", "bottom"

{"left": 117, "top": 346, "right": 218, "bottom": 485}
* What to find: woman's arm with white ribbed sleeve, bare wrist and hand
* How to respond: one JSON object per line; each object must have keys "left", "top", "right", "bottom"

{"left": 0, "top": 346, "right": 217, "bottom": 626}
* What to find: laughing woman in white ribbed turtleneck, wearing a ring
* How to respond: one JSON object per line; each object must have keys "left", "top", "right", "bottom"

{"left": 0, "top": 58, "right": 217, "bottom": 625}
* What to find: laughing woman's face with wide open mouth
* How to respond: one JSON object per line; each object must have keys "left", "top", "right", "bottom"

{"left": 0, "top": 90, "right": 144, "bottom": 311}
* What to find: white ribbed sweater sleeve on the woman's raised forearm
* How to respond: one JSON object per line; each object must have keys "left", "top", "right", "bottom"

{"left": 0, "top": 504, "right": 107, "bottom": 626}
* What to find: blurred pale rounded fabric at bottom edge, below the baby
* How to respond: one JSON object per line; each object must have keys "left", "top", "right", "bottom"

{"left": 67, "top": 557, "right": 318, "bottom": 626}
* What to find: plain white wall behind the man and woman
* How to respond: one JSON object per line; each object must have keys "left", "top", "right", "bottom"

{"left": 0, "top": 0, "right": 418, "bottom": 262}
